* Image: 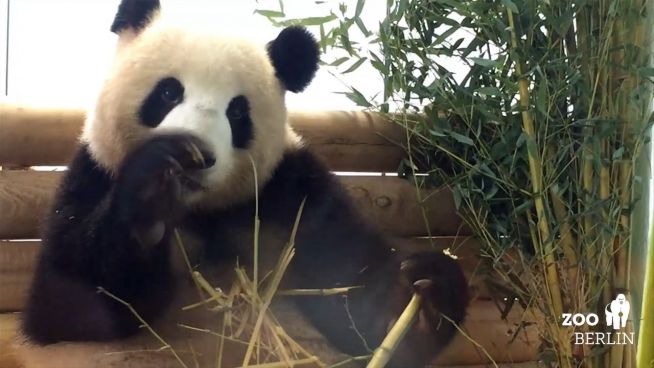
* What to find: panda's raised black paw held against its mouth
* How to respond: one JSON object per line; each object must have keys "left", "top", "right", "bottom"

{"left": 116, "top": 133, "right": 215, "bottom": 224}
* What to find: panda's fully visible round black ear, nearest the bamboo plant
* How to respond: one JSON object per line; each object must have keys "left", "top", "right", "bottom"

{"left": 268, "top": 26, "right": 320, "bottom": 92}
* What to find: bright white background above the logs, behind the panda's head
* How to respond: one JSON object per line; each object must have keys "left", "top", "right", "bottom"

{"left": 0, "top": 0, "right": 385, "bottom": 110}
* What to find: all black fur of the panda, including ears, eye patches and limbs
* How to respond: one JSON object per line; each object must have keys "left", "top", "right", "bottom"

{"left": 23, "top": 0, "right": 468, "bottom": 366}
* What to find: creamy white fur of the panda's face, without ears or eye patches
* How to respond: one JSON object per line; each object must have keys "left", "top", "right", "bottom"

{"left": 81, "top": 13, "right": 301, "bottom": 206}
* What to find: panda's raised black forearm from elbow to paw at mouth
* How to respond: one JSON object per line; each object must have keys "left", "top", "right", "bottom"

{"left": 99, "top": 133, "right": 215, "bottom": 324}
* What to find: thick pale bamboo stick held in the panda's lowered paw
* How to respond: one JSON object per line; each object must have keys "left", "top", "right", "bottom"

{"left": 366, "top": 293, "right": 422, "bottom": 368}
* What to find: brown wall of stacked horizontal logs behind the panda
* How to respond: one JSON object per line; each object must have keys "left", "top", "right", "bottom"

{"left": 0, "top": 104, "right": 538, "bottom": 366}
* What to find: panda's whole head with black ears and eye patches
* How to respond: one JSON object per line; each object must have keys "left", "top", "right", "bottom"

{"left": 82, "top": 0, "right": 319, "bottom": 204}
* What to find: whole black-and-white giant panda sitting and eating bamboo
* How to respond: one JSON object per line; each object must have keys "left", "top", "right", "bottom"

{"left": 20, "top": 0, "right": 468, "bottom": 367}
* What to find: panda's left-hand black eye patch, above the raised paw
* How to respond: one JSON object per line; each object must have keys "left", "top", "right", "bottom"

{"left": 139, "top": 77, "right": 184, "bottom": 128}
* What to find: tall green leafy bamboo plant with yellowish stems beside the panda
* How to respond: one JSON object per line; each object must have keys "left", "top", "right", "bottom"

{"left": 259, "top": 0, "right": 654, "bottom": 368}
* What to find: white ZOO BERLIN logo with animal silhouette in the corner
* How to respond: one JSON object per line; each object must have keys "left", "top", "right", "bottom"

{"left": 562, "top": 294, "right": 634, "bottom": 345}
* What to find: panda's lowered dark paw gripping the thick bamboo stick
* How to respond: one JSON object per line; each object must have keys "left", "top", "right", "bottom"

{"left": 388, "top": 252, "right": 468, "bottom": 366}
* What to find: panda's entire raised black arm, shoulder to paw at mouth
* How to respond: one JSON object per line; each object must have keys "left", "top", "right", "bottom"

{"left": 22, "top": 134, "right": 214, "bottom": 344}
